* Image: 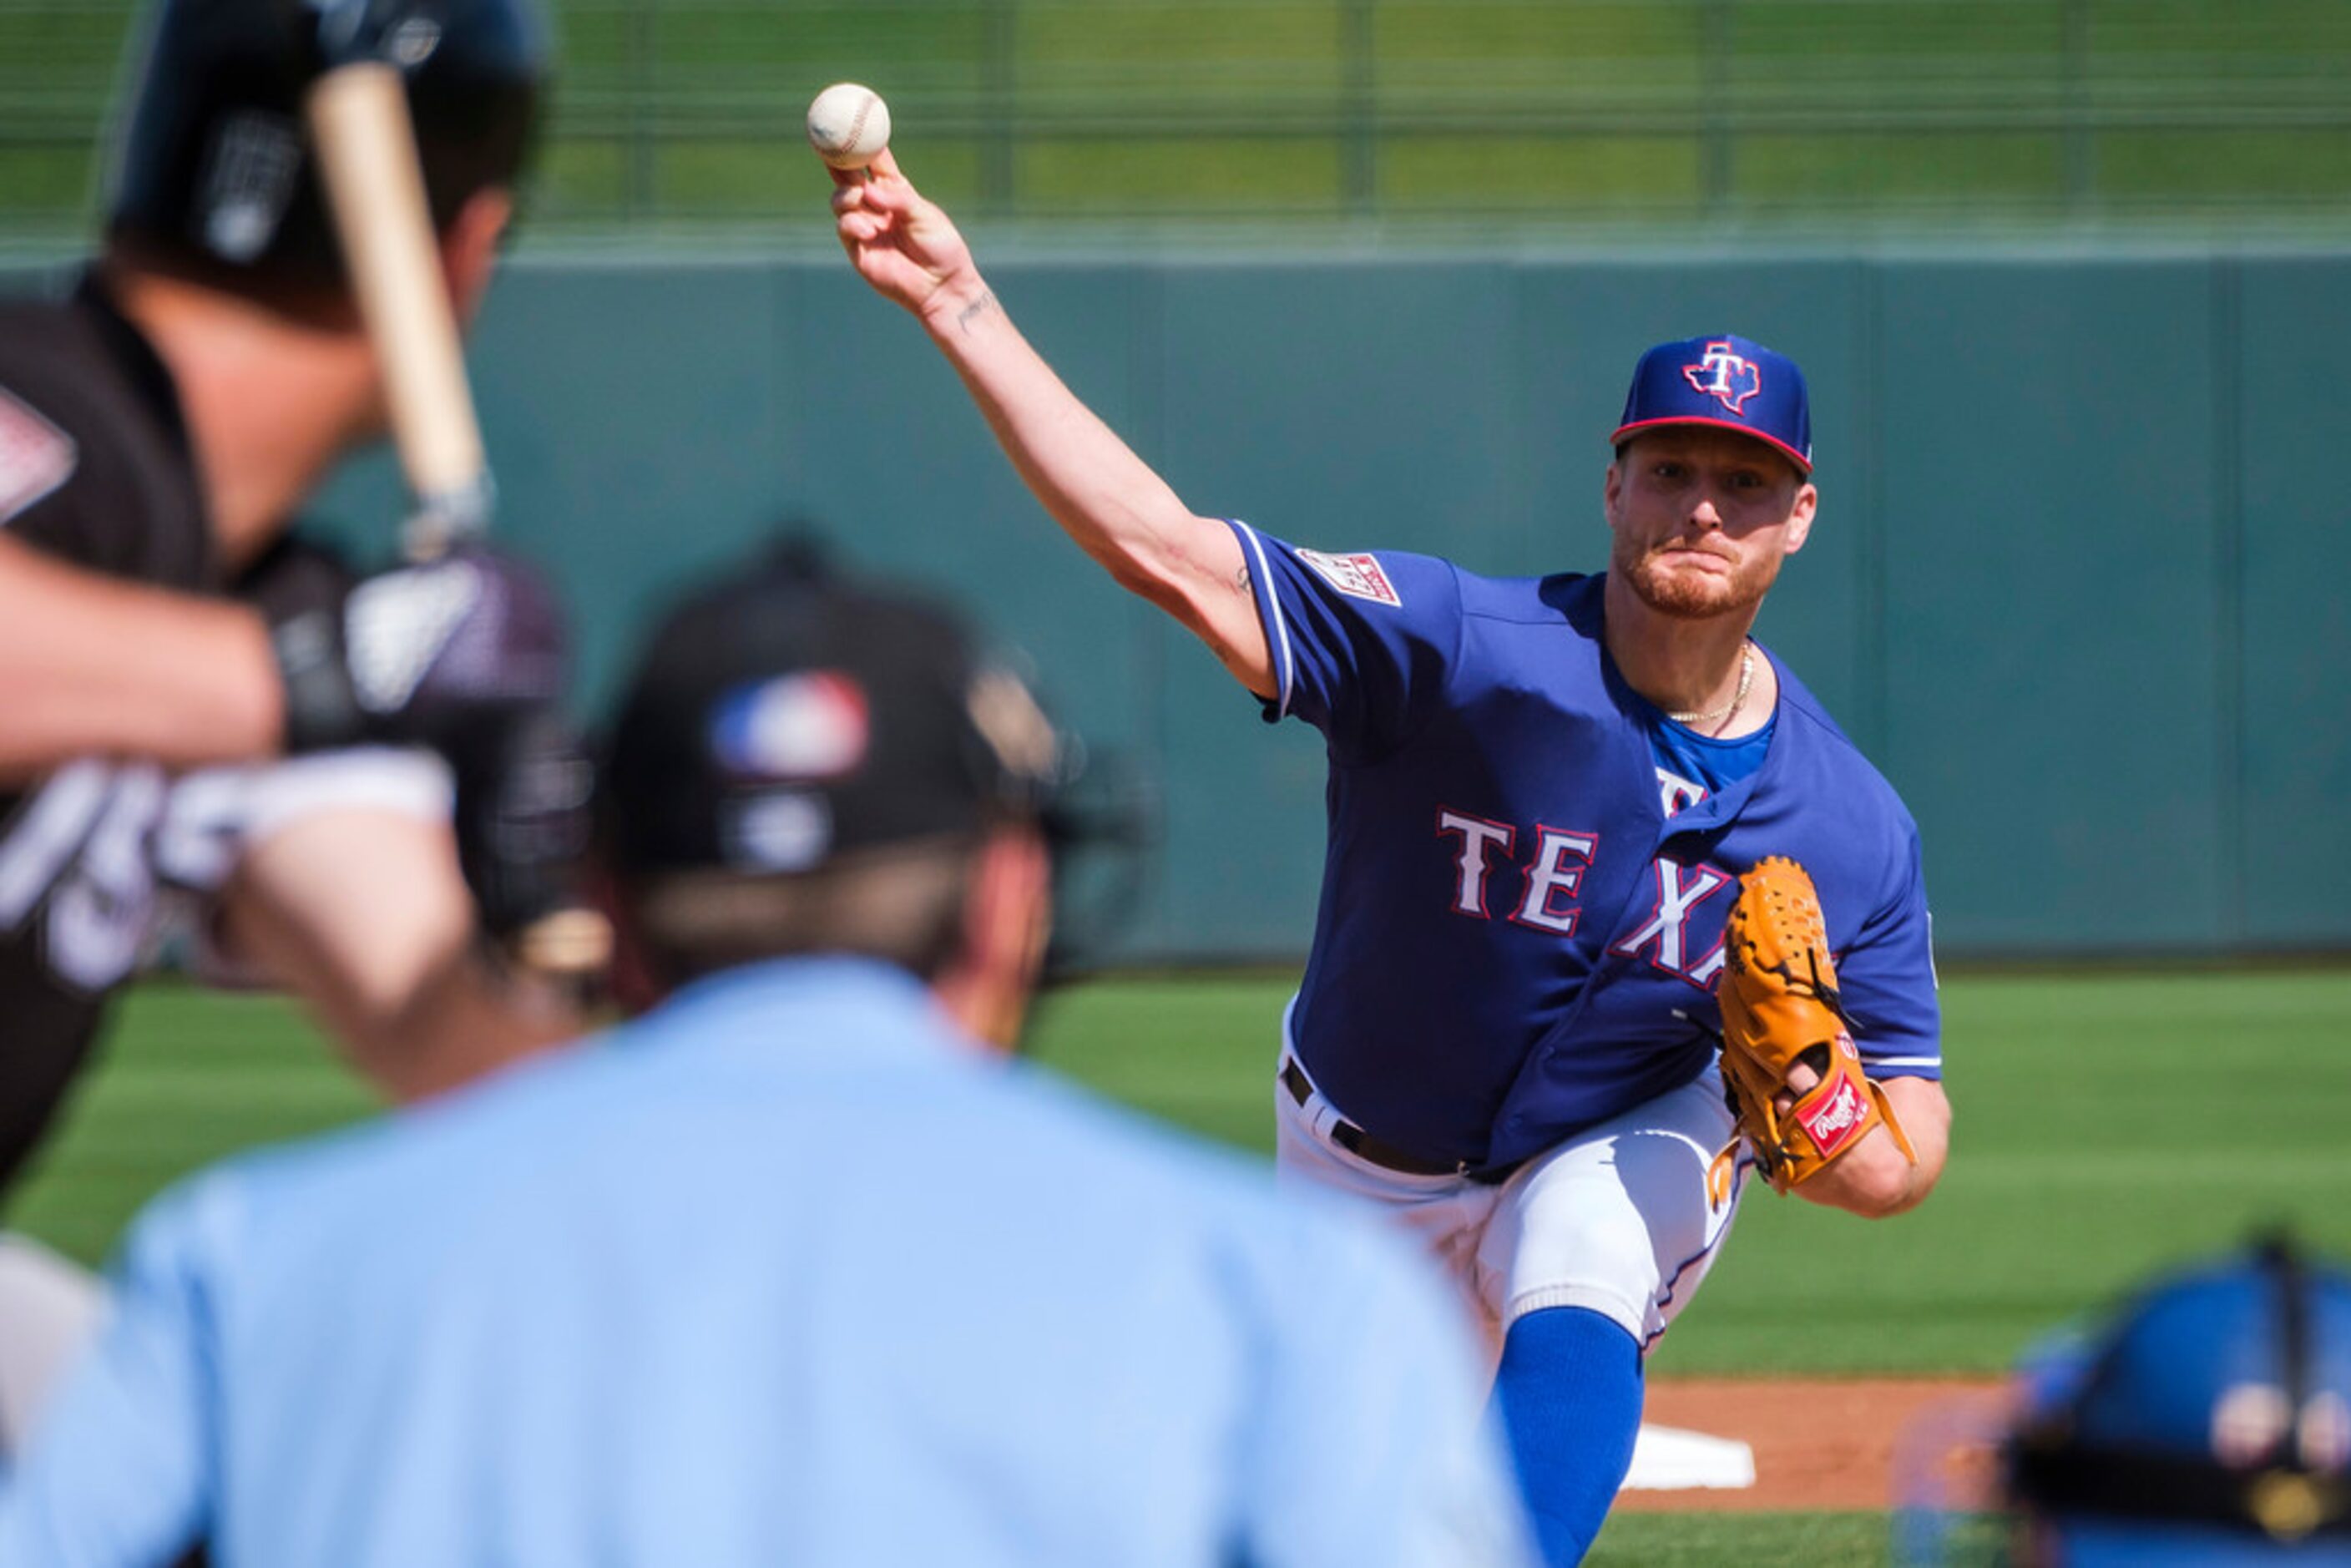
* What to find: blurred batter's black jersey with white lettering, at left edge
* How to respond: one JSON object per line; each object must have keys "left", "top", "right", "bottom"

{"left": 0, "top": 282, "right": 216, "bottom": 1190}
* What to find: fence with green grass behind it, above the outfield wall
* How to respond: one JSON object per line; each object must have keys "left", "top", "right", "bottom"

{"left": 0, "top": 0, "right": 2351, "bottom": 240}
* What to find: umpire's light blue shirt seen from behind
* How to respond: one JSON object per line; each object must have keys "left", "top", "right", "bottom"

{"left": 0, "top": 959, "right": 1526, "bottom": 1568}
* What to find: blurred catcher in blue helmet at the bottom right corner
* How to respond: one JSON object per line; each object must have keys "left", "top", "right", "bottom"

{"left": 1898, "top": 1239, "right": 2351, "bottom": 1568}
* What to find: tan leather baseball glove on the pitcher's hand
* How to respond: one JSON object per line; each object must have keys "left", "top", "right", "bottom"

{"left": 1709, "top": 856, "right": 1916, "bottom": 1192}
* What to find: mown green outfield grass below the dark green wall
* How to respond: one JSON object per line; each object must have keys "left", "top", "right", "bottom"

{"left": 9, "top": 971, "right": 2351, "bottom": 1373}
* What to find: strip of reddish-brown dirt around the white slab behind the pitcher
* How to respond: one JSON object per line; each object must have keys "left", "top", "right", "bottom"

{"left": 1617, "top": 1378, "right": 2000, "bottom": 1514}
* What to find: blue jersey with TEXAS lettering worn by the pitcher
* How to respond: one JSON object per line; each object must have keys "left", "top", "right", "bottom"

{"left": 1234, "top": 524, "right": 1942, "bottom": 1171}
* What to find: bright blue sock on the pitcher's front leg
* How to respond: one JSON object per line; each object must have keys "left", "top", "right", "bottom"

{"left": 1493, "top": 1307, "right": 1641, "bottom": 1568}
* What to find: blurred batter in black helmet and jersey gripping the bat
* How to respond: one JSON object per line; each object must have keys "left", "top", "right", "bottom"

{"left": 0, "top": 0, "right": 569, "bottom": 1455}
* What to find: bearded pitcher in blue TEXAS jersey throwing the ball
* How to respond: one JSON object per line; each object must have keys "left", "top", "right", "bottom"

{"left": 832, "top": 153, "right": 1949, "bottom": 1563}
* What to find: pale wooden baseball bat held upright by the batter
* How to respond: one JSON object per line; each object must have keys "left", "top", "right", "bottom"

{"left": 306, "top": 70, "right": 611, "bottom": 975}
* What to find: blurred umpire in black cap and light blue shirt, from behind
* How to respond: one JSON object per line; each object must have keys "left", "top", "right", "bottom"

{"left": 0, "top": 550, "right": 1526, "bottom": 1568}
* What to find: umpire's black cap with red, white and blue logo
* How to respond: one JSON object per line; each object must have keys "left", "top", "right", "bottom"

{"left": 599, "top": 543, "right": 1063, "bottom": 884}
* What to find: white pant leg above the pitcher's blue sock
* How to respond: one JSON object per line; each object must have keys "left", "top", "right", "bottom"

{"left": 1476, "top": 1067, "right": 1744, "bottom": 1352}
